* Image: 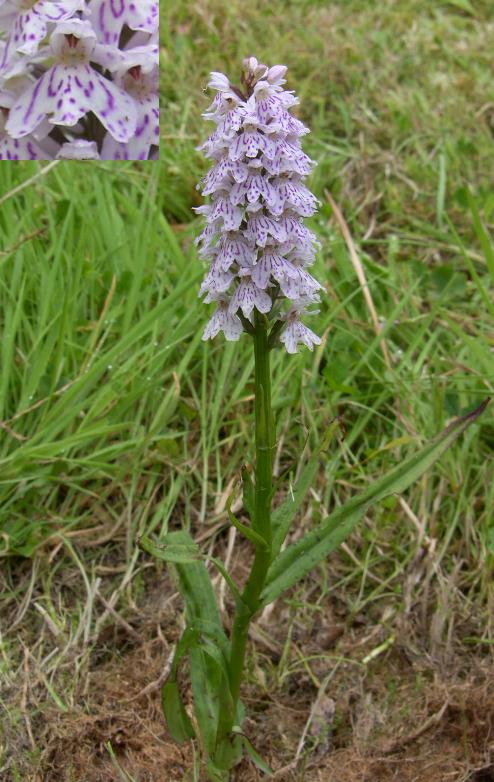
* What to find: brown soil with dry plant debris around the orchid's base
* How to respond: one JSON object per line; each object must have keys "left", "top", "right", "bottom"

{"left": 22, "top": 576, "right": 494, "bottom": 782}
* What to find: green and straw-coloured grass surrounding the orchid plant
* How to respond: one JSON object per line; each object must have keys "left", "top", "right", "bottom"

{"left": 0, "top": 0, "right": 494, "bottom": 780}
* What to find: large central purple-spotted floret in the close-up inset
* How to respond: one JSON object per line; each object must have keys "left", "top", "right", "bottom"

{"left": 6, "top": 19, "right": 136, "bottom": 142}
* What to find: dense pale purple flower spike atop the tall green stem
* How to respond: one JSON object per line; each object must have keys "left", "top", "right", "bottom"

{"left": 196, "top": 57, "right": 322, "bottom": 353}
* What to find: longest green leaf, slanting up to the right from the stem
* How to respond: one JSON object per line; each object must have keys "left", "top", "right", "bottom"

{"left": 259, "top": 399, "right": 490, "bottom": 608}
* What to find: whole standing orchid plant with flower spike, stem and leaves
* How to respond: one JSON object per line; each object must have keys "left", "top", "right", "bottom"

{"left": 140, "top": 57, "right": 486, "bottom": 782}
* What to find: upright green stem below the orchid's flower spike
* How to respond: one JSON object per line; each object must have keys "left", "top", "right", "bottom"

{"left": 226, "top": 310, "right": 276, "bottom": 707}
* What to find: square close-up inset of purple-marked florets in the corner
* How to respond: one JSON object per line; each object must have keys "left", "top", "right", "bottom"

{"left": 0, "top": 0, "right": 159, "bottom": 160}
